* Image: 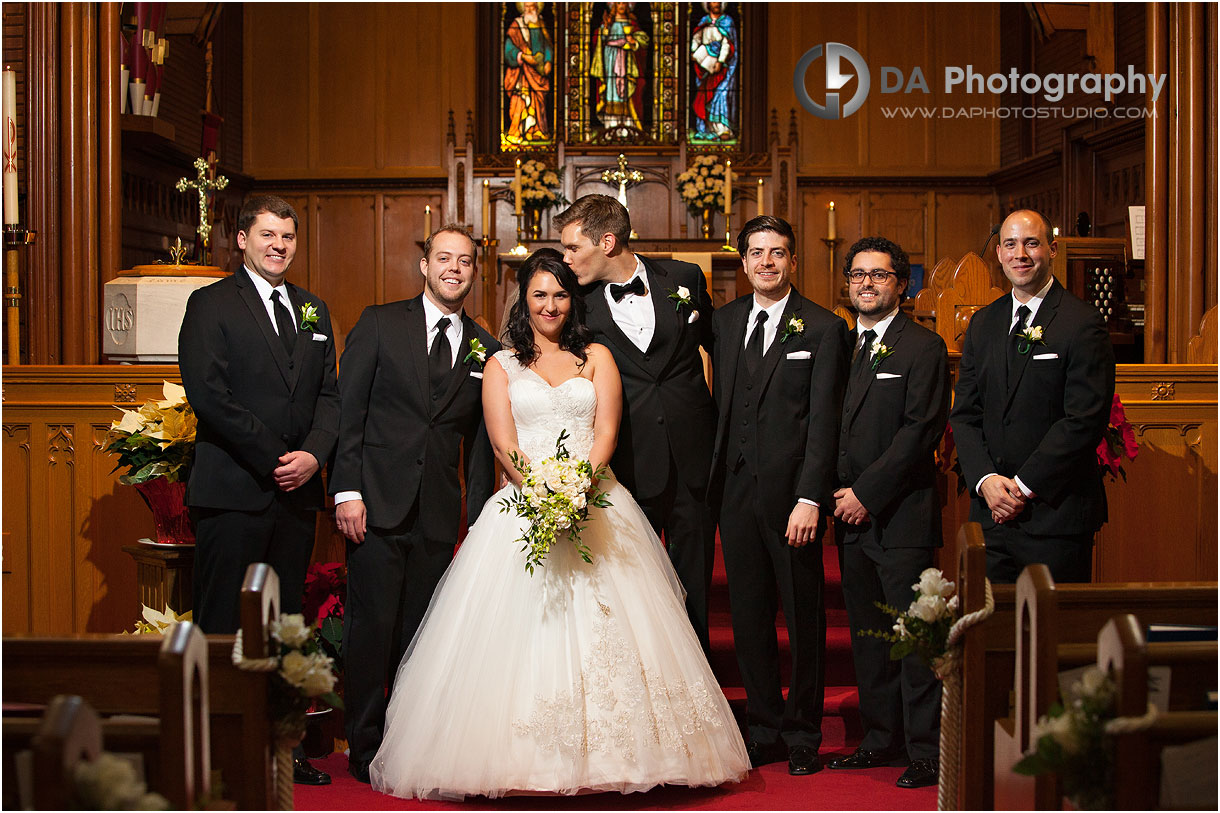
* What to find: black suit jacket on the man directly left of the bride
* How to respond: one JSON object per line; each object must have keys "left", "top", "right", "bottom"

{"left": 331, "top": 294, "right": 500, "bottom": 542}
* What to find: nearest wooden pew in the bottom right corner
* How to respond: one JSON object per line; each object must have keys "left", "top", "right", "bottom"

{"left": 1097, "top": 613, "right": 1216, "bottom": 811}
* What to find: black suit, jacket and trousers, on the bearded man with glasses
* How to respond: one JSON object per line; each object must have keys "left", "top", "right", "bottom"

{"left": 836, "top": 311, "right": 949, "bottom": 759}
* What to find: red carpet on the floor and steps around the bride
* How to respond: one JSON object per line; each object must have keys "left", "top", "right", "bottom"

{"left": 295, "top": 534, "right": 936, "bottom": 811}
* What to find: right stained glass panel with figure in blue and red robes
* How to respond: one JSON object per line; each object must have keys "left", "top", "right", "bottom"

{"left": 684, "top": 2, "right": 742, "bottom": 144}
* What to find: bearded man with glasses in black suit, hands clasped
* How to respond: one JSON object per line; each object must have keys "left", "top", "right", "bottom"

{"left": 828, "top": 237, "right": 949, "bottom": 787}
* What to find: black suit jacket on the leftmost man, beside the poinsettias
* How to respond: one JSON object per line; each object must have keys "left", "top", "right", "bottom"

{"left": 178, "top": 267, "right": 339, "bottom": 511}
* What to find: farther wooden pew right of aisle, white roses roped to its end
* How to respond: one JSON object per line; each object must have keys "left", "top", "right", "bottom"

{"left": 956, "top": 522, "right": 1216, "bottom": 809}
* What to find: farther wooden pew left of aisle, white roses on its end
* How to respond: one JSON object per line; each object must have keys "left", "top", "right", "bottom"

{"left": 2, "top": 563, "right": 279, "bottom": 809}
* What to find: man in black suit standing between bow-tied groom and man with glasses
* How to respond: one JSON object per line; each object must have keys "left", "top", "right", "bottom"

{"left": 711, "top": 216, "right": 848, "bottom": 775}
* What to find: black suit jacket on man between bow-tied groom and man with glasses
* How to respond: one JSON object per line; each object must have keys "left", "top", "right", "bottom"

{"left": 711, "top": 288, "right": 849, "bottom": 531}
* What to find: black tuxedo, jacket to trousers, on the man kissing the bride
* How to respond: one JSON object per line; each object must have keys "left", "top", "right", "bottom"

{"left": 584, "top": 256, "right": 716, "bottom": 649}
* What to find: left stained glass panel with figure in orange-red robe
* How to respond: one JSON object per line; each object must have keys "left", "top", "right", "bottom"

{"left": 500, "top": 2, "right": 558, "bottom": 151}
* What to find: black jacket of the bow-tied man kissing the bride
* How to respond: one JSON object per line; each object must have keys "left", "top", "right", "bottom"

{"left": 584, "top": 256, "right": 716, "bottom": 498}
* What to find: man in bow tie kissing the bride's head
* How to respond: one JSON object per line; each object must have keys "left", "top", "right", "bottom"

{"left": 554, "top": 195, "right": 716, "bottom": 652}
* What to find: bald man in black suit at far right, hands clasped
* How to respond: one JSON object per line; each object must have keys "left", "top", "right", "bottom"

{"left": 949, "top": 209, "right": 1114, "bottom": 582}
